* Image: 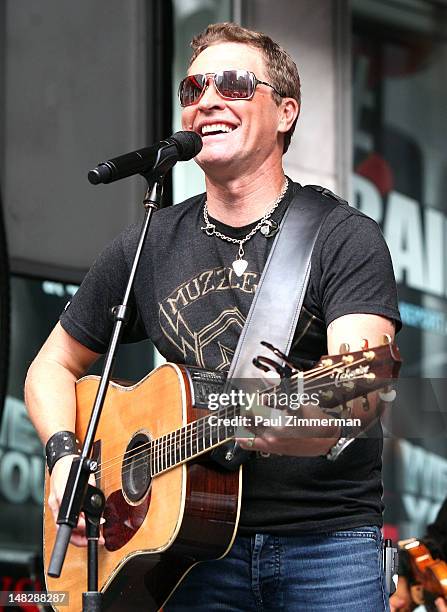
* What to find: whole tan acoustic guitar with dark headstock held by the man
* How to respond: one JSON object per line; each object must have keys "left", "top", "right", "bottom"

{"left": 44, "top": 337, "right": 401, "bottom": 612}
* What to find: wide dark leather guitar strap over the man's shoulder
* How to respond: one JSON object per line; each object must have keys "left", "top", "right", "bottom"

{"left": 212, "top": 185, "right": 345, "bottom": 470}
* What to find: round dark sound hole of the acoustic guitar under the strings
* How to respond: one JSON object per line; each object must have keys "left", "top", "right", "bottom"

{"left": 121, "top": 432, "right": 151, "bottom": 503}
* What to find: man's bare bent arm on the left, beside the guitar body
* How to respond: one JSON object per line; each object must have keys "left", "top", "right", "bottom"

{"left": 25, "top": 323, "right": 99, "bottom": 546}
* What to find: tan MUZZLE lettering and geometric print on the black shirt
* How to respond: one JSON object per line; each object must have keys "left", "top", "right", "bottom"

{"left": 158, "top": 267, "right": 259, "bottom": 370}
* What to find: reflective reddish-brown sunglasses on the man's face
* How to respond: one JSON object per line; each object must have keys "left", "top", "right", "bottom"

{"left": 178, "top": 70, "right": 284, "bottom": 107}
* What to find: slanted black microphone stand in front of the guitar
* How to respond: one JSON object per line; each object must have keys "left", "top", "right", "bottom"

{"left": 48, "top": 172, "right": 166, "bottom": 612}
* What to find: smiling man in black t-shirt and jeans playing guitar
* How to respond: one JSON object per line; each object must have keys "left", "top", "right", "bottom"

{"left": 26, "top": 23, "right": 400, "bottom": 612}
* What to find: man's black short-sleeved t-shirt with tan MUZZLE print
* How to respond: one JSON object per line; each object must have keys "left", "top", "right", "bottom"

{"left": 60, "top": 183, "right": 400, "bottom": 533}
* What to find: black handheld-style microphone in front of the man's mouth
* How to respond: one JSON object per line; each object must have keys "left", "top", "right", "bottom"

{"left": 87, "top": 131, "right": 202, "bottom": 185}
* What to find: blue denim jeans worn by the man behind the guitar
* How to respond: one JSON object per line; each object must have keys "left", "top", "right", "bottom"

{"left": 164, "top": 527, "right": 389, "bottom": 612}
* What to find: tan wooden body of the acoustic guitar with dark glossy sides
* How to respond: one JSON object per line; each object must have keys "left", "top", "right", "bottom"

{"left": 44, "top": 364, "right": 241, "bottom": 612}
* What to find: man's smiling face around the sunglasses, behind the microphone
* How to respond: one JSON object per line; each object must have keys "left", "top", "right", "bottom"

{"left": 182, "top": 42, "right": 288, "bottom": 176}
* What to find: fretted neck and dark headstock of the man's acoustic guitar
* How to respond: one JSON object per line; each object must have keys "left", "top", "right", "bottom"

{"left": 149, "top": 336, "right": 401, "bottom": 476}
